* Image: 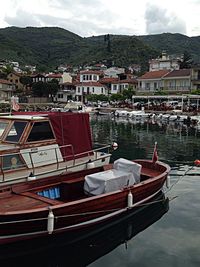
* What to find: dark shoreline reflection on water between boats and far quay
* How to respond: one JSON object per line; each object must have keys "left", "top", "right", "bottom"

{"left": 91, "top": 116, "right": 200, "bottom": 165}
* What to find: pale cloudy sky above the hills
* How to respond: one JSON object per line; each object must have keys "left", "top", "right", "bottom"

{"left": 0, "top": 0, "right": 200, "bottom": 37}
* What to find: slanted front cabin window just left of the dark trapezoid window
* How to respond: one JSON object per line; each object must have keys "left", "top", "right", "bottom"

{"left": 5, "top": 121, "right": 27, "bottom": 143}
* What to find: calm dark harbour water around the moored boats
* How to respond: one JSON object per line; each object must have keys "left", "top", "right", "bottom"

{"left": 1, "top": 116, "right": 200, "bottom": 267}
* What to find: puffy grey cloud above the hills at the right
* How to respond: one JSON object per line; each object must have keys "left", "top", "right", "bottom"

{"left": 145, "top": 4, "right": 186, "bottom": 34}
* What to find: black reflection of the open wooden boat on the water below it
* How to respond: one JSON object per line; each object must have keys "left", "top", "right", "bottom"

{"left": 0, "top": 192, "right": 169, "bottom": 267}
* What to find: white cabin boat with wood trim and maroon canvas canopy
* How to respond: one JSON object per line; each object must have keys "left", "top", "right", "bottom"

{"left": 0, "top": 112, "right": 111, "bottom": 186}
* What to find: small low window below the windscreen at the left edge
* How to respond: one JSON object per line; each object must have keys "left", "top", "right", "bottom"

{"left": 1, "top": 154, "right": 25, "bottom": 171}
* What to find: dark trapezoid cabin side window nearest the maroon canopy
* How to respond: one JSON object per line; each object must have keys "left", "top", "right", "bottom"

{"left": 27, "top": 121, "right": 55, "bottom": 142}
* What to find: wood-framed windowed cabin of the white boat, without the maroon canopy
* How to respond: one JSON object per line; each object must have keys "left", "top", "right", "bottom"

{"left": 0, "top": 115, "right": 61, "bottom": 171}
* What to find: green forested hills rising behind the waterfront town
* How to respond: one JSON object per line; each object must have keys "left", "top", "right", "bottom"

{"left": 0, "top": 27, "right": 200, "bottom": 69}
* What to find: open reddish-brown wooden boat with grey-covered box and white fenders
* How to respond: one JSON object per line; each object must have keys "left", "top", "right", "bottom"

{"left": 0, "top": 159, "right": 170, "bottom": 244}
